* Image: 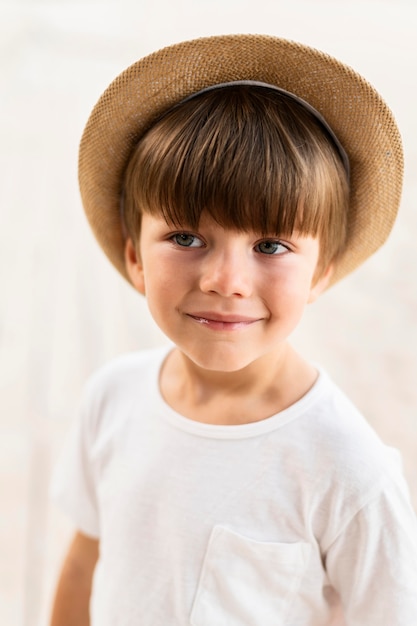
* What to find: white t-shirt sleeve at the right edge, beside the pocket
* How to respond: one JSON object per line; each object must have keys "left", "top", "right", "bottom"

{"left": 325, "top": 468, "right": 417, "bottom": 626}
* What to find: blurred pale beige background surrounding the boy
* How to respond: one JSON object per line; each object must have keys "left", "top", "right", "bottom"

{"left": 0, "top": 0, "right": 417, "bottom": 626}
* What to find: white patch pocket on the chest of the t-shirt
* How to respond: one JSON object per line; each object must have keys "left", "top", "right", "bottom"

{"left": 190, "top": 526, "right": 311, "bottom": 626}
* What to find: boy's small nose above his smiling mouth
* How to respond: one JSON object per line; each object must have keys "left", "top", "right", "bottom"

{"left": 200, "top": 242, "right": 253, "bottom": 298}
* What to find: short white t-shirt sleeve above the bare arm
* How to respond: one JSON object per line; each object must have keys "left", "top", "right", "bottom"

{"left": 50, "top": 378, "right": 100, "bottom": 538}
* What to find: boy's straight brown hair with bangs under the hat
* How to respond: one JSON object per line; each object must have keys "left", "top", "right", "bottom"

{"left": 123, "top": 85, "right": 349, "bottom": 270}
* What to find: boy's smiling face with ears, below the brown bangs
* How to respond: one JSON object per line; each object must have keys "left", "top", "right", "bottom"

{"left": 126, "top": 214, "right": 328, "bottom": 372}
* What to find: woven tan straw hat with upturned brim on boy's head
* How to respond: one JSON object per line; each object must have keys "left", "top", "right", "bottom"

{"left": 79, "top": 35, "right": 403, "bottom": 283}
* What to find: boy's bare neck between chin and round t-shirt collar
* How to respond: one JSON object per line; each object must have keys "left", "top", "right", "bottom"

{"left": 160, "top": 344, "right": 317, "bottom": 424}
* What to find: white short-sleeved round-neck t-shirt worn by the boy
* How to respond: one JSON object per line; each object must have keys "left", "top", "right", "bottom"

{"left": 53, "top": 348, "right": 417, "bottom": 626}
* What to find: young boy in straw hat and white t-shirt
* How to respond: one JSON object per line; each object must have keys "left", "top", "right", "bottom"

{"left": 52, "top": 35, "right": 417, "bottom": 626}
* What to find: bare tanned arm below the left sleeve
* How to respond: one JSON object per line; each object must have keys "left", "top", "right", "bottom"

{"left": 50, "top": 532, "right": 99, "bottom": 626}
